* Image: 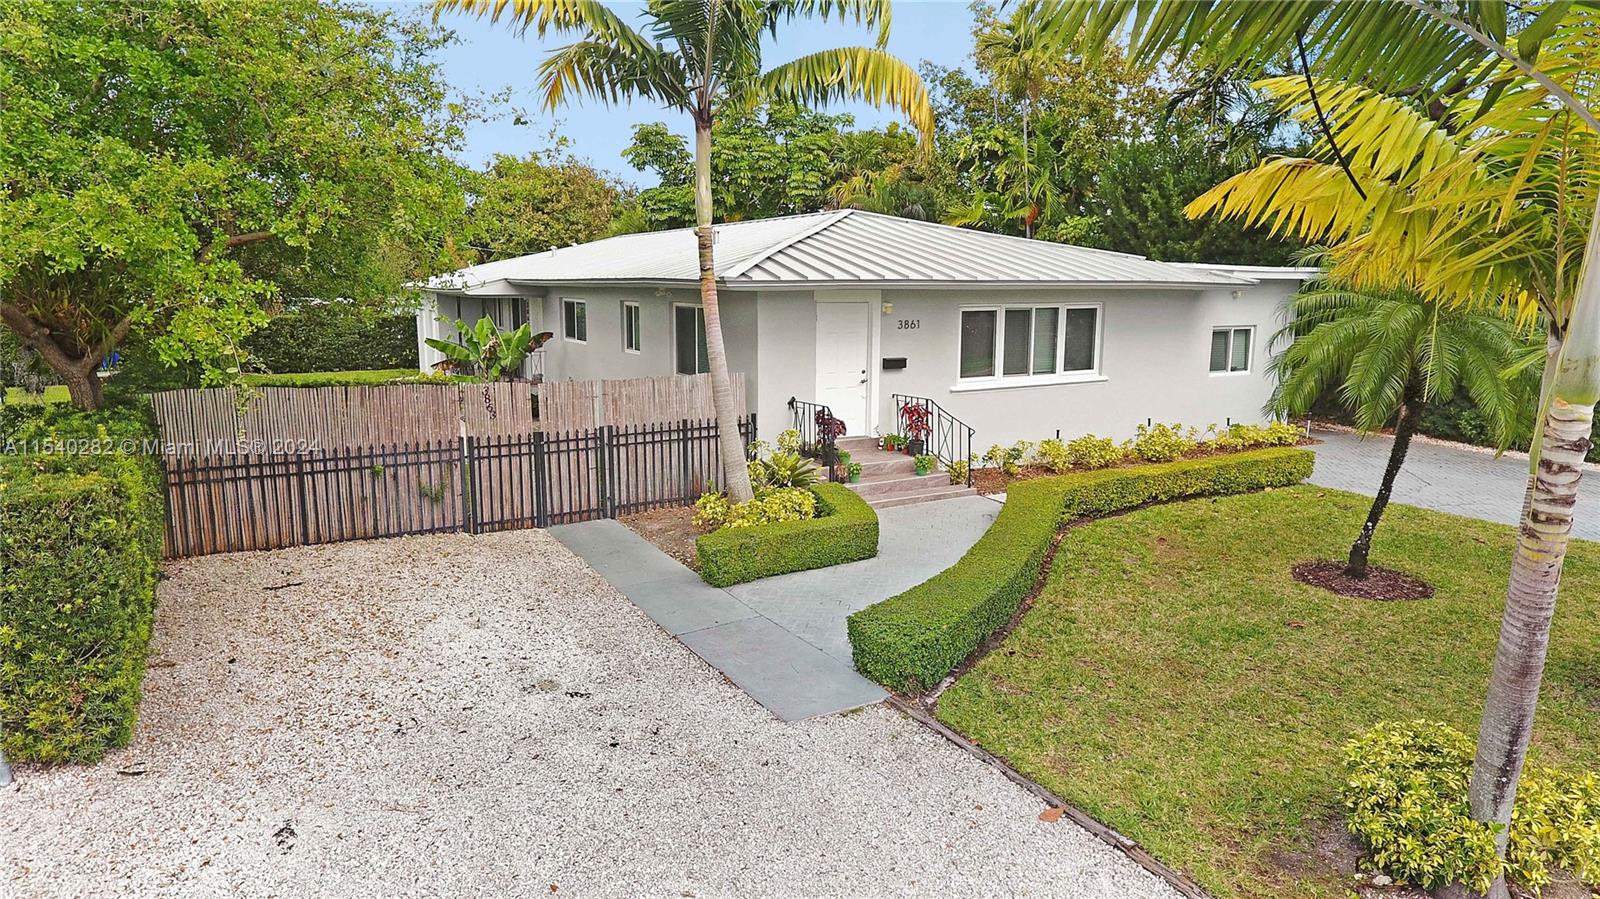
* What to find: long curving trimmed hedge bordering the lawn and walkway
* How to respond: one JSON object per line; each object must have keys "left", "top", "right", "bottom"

{"left": 848, "top": 448, "right": 1312, "bottom": 693}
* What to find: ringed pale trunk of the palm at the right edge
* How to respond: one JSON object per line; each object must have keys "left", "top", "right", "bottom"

{"left": 1469, "top": 208, "right": 1600, "bottom": 899}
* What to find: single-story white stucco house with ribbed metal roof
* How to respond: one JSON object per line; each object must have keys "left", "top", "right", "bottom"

{"left": 418, "top": 210, "right": 1314, "bottom": 453}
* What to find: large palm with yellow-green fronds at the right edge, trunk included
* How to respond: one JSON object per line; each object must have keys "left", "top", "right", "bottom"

{"left": 1045, "top": 0, "right": 1600, "bottom": 897}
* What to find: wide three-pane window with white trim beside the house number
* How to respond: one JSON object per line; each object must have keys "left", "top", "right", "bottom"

{"left": 958, "top": 304, "right": 1099, "bottom": 382}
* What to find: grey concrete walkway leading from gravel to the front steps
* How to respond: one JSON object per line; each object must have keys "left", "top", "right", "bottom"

{"left": 550, "top": 496, "right": 1000, "bottom": 721}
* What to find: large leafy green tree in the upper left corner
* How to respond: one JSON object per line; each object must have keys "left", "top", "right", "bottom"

{"left": 0, "top": 0, "right": 461, "bottom": 408}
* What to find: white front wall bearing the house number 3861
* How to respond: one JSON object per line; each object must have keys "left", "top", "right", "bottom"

{"left": 864, "top": 280, "right": 1294, "bottom": 444}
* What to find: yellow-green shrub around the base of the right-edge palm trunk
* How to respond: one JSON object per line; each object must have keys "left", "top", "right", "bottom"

{"left": 1342, "top": 720, "right": 1600, "bottom": 894}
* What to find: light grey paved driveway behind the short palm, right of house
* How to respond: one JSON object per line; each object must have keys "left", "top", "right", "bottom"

{"left": 1310, "top": 430, "right": 1600, "bottom": 541}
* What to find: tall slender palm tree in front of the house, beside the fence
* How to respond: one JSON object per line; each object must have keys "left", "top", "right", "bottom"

{"left": 435, "top": 0, "right": 933, "bottom": 501}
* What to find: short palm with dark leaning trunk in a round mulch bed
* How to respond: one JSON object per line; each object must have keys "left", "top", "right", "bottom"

{"left": 1267, "top": 280, "right": 1542, "bottom": 577}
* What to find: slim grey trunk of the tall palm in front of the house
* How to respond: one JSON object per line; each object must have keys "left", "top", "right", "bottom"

{"left": 694, "top": 115, "right": 755, "bottom": 502}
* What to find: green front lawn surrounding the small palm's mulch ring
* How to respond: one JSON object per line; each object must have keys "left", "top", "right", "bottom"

{"left": 938, "top": 486, "right": 1600, "bottom": 897}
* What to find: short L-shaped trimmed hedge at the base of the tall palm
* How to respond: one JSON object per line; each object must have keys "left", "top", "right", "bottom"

{"left": 694, "top": 483, "right": 878, "bottom": 587}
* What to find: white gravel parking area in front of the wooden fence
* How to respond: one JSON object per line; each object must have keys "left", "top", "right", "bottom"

{"left": 0, "top": 531, "right": 1176, "bottom": 899}
